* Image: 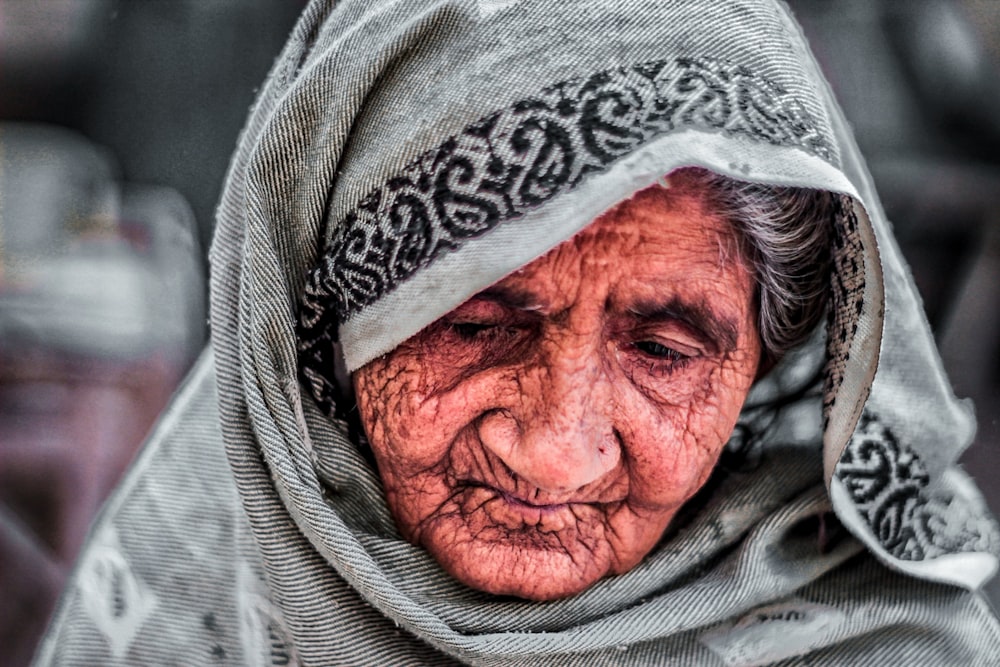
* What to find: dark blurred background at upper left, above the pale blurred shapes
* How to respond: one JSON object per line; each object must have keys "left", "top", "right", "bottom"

{"left": 0, "top": 0, "right": 305, "bottom": 248}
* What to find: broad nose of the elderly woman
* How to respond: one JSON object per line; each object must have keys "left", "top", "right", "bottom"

{"left": 479, "top": 352, "right": 621, "bottom": 494}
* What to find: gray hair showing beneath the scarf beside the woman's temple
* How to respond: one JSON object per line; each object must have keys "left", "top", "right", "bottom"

{"left": 683, "top": 168, "right": 842, "bottom": 361}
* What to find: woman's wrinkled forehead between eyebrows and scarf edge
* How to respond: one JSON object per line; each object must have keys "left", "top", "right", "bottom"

{"left": 487, "top": 180, "right": 753, "bottom": 319}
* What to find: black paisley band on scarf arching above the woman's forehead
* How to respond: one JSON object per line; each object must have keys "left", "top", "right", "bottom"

{"left": 298, "top": 58, "right": 836, "bottom": 418}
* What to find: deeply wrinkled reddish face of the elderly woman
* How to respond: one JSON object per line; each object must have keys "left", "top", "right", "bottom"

{"left": 354, "top": 180, "right": 760, "bottom": 600}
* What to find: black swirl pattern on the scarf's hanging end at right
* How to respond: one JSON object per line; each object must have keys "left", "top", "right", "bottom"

{"left": 834, "top": 412, "right": 1000, "bottom": 560}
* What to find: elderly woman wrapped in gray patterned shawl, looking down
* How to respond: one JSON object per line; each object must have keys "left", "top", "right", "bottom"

{"left": 38, "top": 0, "right": 1000, "bottom": 665}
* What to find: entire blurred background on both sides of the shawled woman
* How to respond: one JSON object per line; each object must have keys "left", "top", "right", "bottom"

{"left": 0, "top": 0, "right": 1000, "bottom": 667}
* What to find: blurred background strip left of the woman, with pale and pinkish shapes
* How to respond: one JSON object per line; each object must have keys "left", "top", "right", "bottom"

{"left": 0, "top": 0, "right": 305, "bottom": 667}
